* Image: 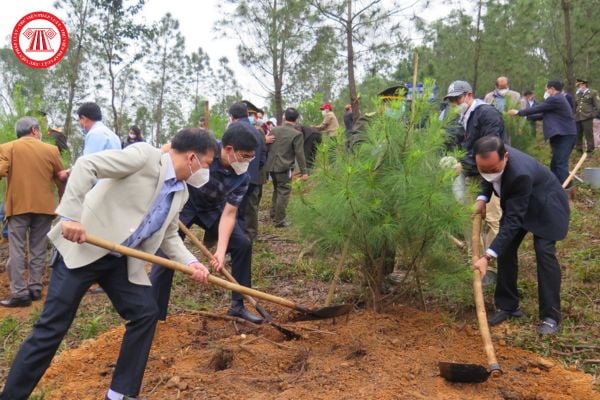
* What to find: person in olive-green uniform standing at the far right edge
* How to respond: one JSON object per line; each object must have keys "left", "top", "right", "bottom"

{"left": 575, "top": 78, "right": 600, "bottom": 154}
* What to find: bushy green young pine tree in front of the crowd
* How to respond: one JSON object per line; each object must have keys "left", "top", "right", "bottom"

{"left": 290, "top": 82, "right": 468, "bottom": 306}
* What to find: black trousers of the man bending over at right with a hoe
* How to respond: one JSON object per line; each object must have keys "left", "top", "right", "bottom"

{"left": 494, "top": 229, "right": 561, "bottom": 321}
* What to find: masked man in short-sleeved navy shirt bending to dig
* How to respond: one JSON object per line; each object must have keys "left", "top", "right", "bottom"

{"left": 150, "top": 122, "right": 262, "bottom": 323}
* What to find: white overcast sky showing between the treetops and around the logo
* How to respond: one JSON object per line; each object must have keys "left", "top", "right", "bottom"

{"left": 0, "top": 0, "right": 452, "bottom": 107}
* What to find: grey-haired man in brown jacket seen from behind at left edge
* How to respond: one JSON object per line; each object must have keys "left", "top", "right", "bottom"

{"left": 0, "top": 117, "right": 66, "bottom": 307}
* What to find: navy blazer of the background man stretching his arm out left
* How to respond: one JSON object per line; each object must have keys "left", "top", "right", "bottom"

{"left": 518, "top": 93, "right": 577, "bottom": 140}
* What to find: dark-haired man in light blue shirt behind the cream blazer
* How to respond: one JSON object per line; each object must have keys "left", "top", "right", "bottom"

{"left": 77, "top": 102, "right": 121, "bottom": 156}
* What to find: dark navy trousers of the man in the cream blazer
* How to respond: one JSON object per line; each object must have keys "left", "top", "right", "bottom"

{"left": 0, "top": 255, "right": 157, "bottom": 400}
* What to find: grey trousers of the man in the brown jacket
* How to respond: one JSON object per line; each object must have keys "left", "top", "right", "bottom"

{"left": 6, "top": 213, "right": 54, "bottom": 297}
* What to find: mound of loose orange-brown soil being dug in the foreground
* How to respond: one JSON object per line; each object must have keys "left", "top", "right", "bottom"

{"left": 41, "top": 306, "right": 600, "bottom": 400}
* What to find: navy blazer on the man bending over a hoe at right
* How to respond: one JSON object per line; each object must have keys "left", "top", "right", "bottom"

{"left": 480, "top": 146, "right": 569, "bottom": 255}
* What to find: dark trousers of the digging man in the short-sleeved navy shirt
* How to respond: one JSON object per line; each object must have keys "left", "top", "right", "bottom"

{"left": 150, "top": 208, "right": 252, "bottom": 321}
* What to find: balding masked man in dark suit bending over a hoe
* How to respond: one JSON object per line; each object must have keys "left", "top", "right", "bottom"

{"left": 473, "top": 136, "right": 569, "bottom": 335}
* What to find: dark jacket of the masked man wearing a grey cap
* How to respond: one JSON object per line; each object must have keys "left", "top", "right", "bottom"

{"left": 461, "top": 103, "right": 506, "bottom": 176}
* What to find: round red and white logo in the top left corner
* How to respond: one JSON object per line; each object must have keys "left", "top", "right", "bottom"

{"left": 11, "top": 11, "right": 69, "bottom": 68}
